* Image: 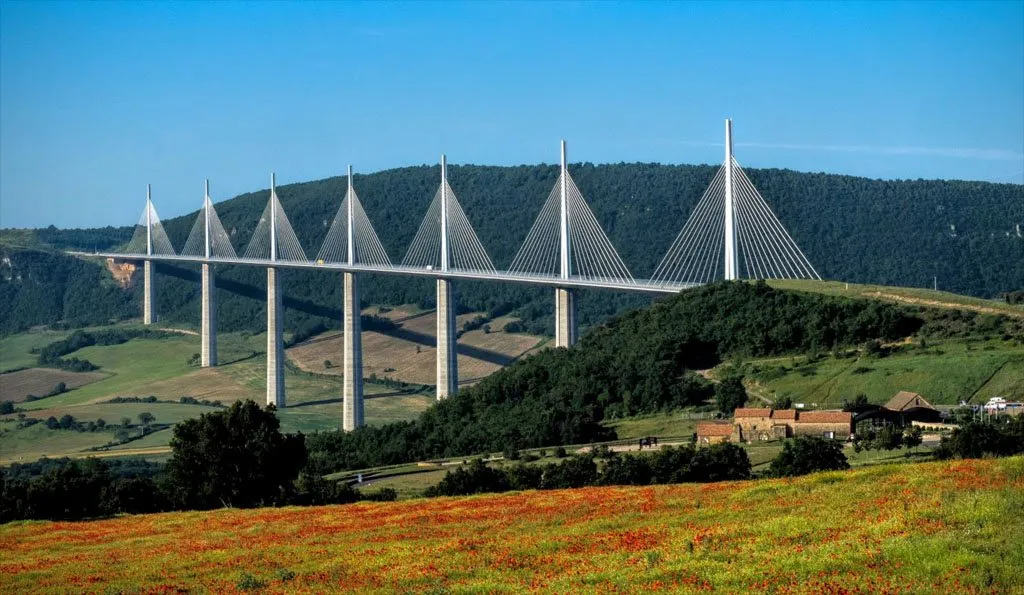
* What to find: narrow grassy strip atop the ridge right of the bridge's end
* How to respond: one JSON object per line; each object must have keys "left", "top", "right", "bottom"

{"left": 768, "top": 280, "right": 1024, "bottom": 317}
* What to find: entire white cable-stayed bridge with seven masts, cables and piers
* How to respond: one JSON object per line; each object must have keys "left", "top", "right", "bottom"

{"left": 75, "top": 120, "right": 820, "bottom": 430}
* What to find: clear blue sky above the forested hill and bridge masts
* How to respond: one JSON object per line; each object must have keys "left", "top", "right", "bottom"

{"left": 0, "top": 1, "right": 1024, "bottom": 227}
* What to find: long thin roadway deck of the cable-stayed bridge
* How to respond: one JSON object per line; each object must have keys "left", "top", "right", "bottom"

{"left": 68, "top": 251, "right": 699, "bottom": 295}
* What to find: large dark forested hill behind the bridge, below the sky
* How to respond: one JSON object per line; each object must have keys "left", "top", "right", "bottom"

{"left": 0, "top": 164, "right": 1024, "bottom": 330}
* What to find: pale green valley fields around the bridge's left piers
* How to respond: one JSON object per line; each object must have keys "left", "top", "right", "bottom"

{"left": 0, "top": 327, "right": 434, "bottom": 463}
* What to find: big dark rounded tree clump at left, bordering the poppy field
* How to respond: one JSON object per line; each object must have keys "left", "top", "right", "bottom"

{"left": 167, "top": 400, "right": 306, "bottom": 509}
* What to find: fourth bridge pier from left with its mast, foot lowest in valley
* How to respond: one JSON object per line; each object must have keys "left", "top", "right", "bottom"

{"left": 341, "top": 166, "right": 364, "bottom": 432}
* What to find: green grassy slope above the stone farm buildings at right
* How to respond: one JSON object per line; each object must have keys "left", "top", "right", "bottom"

{"left": 748, "top": 341, "right": 1024, "bottom": 408}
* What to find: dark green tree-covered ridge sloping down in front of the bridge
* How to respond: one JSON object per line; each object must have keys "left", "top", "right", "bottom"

{"left": 308, "top": 283, "right": 924, "bottom": 472}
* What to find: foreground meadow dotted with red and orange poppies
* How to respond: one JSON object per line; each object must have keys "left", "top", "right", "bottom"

{"left": 0, "top": 457, "right": 1024, "bottom": 594}
